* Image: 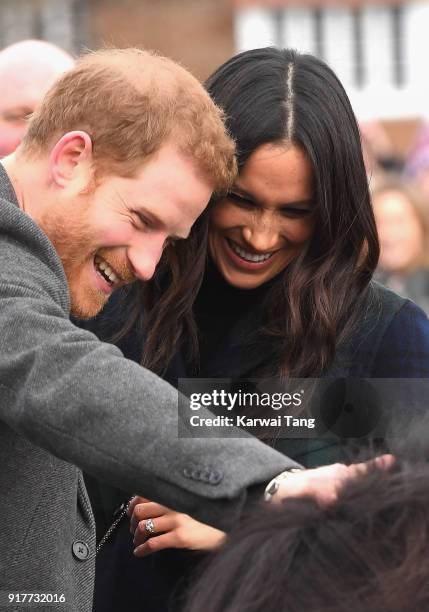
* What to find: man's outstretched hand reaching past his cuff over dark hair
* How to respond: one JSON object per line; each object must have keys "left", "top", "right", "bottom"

{"left": 272, "top": 455, "right": 395, "bottom": 507}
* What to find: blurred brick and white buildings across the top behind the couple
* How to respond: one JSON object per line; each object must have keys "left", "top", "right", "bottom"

{"left": 0, "top": 0, "right": 429, "bottom": 125}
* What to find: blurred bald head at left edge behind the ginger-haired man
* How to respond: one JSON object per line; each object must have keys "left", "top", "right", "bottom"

{"left": 0, "top": 40, "right": 74, "bottom": 158}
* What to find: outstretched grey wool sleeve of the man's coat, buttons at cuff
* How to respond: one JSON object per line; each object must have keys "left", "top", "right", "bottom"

{"left": 0, "top": 280, "right": 296, "bottom": 529}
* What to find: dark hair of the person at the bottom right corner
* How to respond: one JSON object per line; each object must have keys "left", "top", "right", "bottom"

{"left": 183, "top": 460, "right": 429, "bottom": 612}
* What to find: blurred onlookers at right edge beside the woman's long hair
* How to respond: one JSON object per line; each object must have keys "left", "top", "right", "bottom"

{"left": 361, "top": 122, "right": 429, "bottom": 313}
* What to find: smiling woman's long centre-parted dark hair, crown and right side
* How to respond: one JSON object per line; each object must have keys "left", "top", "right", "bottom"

{"left": 206, "top": 47, "right": 379, "bottom": 376}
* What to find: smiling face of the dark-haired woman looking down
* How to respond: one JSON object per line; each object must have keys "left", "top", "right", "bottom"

{"left": 209, "top": 143, "right": 314, "bottom": 289}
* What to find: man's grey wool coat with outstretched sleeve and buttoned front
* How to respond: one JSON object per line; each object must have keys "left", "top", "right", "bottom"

{"left": 0, "top": 164, "right": 295, "bottom": 612}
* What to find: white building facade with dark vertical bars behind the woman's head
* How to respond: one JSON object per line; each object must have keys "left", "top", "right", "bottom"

{"left": 234, "top": 0, "right": 429, "bottom": 120}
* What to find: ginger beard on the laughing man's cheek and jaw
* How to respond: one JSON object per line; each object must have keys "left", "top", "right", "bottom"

{"left": 39, "top": 202, "right": 135, "bottom": 319}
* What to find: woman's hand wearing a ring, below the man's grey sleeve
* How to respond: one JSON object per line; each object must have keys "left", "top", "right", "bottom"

{"left": 128, "top": 497, "right": 226, "bottom": 557}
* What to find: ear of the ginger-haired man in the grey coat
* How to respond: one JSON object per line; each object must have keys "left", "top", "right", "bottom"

{"left": 49, "top": 131, "right": 94, "bottom": 193}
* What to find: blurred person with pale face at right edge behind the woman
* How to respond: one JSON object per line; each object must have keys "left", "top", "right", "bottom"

{"left": 372, "top": 177, "right": 429, "bottom": 313}
